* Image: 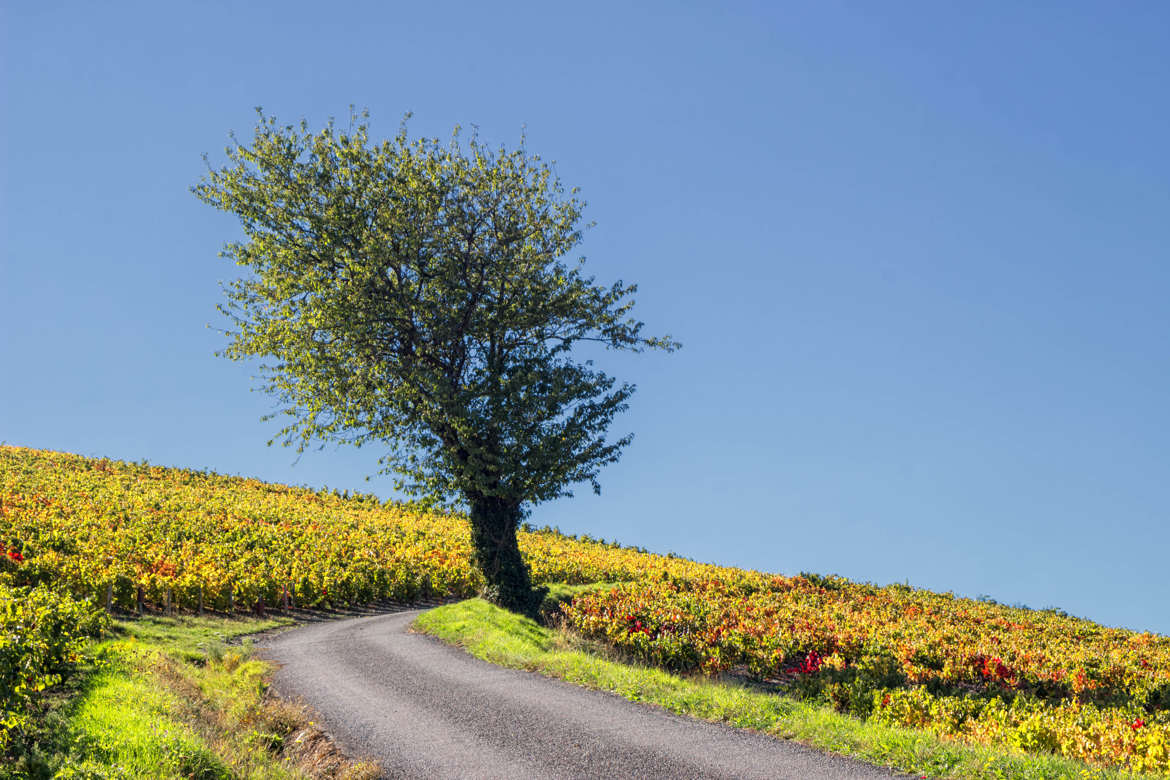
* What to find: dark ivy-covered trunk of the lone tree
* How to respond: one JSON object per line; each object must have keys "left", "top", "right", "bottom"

{"left": 469, "top": 497, "right": 548, "bottom": 617}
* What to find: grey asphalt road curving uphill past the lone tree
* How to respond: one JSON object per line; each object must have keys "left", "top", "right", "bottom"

{"left": 260, "top": 610, "right": 904, "bottom": 780}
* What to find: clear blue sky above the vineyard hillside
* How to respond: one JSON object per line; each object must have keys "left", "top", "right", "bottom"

{"left": 0, "top": 0, "right": 1170, "bottom": 634}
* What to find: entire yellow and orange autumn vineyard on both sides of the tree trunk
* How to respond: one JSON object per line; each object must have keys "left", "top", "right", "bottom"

{"left": 0, "top": 447, "right": 1170, "bottom": 773}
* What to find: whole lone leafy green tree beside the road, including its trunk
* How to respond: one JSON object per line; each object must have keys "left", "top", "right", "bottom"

{"left": 193, "top": 112, "right": 679, "bottom": 613}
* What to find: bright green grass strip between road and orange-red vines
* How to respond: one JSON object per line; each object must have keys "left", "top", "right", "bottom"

{"left": 414, "top": 599, "right": 1155, "bottom": 780}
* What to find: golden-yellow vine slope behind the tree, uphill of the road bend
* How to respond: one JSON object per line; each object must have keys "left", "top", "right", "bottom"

{"left": 0, "top": 447, "right": 737, "bottom": 610}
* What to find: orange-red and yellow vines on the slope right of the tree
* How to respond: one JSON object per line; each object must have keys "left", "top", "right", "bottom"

{"left": 564, "top": 572, "right": 1170, "bottom": 772}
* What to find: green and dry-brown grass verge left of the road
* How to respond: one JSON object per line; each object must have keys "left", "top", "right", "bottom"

{"left": 7, "top": 617, "right": 379, "bottom": 780}
